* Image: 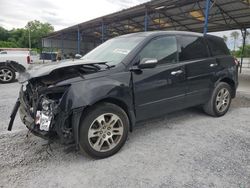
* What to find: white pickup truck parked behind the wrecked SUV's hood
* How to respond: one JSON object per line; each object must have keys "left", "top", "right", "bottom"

{"left": 0, "top": 51, "right": 39, "bottom": 83}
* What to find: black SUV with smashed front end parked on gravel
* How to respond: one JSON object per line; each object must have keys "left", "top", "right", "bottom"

{"left": 8, "top": 31, "right": 238, "bottom": 158}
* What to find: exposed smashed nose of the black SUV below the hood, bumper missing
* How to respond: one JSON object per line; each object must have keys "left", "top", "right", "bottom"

{"left": 19, "top": 82, "right": 73, "bottom": 142}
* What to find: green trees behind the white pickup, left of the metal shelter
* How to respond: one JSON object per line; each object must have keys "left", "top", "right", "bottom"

{"left": 0, "top": 20, "right": 54, "bottom": 49}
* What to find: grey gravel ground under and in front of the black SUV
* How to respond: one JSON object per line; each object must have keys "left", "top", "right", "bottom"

{"left": 0, "top": 83, "right": 250, "bottom": 188}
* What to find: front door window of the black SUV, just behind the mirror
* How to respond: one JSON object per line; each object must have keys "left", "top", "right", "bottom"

{"left": 139, "top": 36, "right": 177, "bottom": 64}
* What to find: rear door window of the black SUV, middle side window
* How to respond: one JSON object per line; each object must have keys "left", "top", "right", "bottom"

{"left": 179, "top": 36, "right": 209, "bottom": 61}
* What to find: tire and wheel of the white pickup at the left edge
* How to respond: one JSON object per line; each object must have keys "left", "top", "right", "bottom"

{"left": 0, "top": 66, "right": 16, "bottom": 83}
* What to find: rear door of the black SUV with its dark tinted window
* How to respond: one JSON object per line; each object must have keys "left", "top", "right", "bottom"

{"left": 178, "top": 35, "right": 218, "bottom": 106}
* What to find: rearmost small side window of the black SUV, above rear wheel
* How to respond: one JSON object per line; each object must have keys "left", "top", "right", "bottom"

{"left": 207, "top": 37, "right": 230, "bottom": 56}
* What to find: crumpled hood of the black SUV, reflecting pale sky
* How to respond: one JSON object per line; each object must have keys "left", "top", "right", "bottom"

{"left": 18, "top": 59, "right": 105, "bottom": 83}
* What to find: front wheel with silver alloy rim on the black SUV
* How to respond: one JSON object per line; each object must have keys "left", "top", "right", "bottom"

{"left": 79, "top": 103, "right": 129, "bottom": 158}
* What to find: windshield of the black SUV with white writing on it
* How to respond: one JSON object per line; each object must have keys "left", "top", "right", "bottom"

{"left": 81, "top": 37, "right": 144, "bottom": 65}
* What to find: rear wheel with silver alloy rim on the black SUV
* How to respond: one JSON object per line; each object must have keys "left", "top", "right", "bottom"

{"left": 203, "top": 82, "right": 232, "bottom": 117}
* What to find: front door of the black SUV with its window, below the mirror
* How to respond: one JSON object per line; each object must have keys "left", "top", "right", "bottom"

{"left": 132, "top": 36, "right": 186, "bottom": 120}
